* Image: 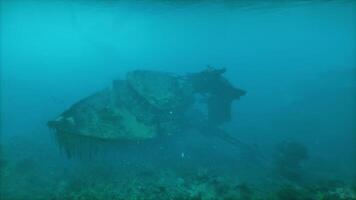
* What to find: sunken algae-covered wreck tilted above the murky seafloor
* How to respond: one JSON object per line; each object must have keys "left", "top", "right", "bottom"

{"left": 48, "top": 67, "right": 245, "bottom": 155}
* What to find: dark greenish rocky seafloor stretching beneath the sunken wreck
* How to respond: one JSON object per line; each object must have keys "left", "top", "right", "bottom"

{"left": 0, "top": 133, "right": 356, "bottom": 200}
